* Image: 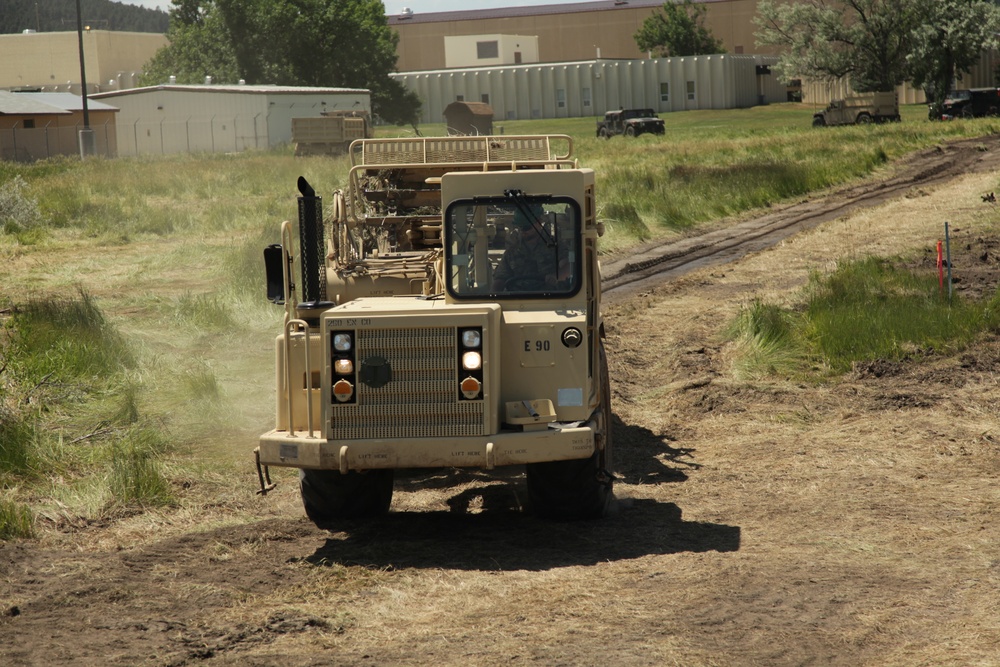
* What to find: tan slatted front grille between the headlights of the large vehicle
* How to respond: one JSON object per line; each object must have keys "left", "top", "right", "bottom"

{"left": 330, "top": 327, "right": 484, "bottom": 440}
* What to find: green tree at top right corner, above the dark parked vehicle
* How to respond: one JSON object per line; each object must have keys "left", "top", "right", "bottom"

{"left": 909, "top": 0, "right": 1000, "bottom": 112}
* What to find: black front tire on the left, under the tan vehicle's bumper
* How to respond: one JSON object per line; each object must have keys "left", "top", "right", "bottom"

{"left": 299, "top": 469, "right": 393, "bottom": 528}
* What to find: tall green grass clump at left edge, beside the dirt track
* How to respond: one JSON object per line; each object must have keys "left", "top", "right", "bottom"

{"left": 0, "top": 289, "right": 173, "bottom": 539}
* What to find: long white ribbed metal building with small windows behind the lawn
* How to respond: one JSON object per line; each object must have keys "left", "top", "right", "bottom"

{"left": 390, "top": 54, "right": 788, "bottom": 123}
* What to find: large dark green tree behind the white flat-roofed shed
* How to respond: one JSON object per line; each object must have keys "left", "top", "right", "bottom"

{"left": 144, "top": 0, "right": 420, "bottom": 124}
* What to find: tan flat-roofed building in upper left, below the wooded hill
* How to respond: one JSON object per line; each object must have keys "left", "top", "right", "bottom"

{"left": 0, "top": 30, "right": 167, "bottom": 95}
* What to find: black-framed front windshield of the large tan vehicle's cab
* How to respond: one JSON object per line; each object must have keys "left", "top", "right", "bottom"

{"left": 445, "top": 195, "right": 580, "bottom": 299}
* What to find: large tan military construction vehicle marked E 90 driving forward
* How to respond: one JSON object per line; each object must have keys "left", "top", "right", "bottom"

{"left": 255, "top": 135, "right": 613, "bottom": 526}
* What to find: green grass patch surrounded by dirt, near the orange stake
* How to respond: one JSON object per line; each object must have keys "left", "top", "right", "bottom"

{"left": 728, "top": 257, "right": 1000, "bottom": 375}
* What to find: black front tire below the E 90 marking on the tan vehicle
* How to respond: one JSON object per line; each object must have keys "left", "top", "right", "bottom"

{"left": 526, "top": 346, "right": 614, "bottom": 520}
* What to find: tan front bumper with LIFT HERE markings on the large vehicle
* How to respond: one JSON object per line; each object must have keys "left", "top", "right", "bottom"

{"left": 258, "top": 421, "right": 597, "bottom": 473}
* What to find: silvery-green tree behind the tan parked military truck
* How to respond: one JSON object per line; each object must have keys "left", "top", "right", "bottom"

{"left": 754, "top": 0, "right": 916, "bottom": 92}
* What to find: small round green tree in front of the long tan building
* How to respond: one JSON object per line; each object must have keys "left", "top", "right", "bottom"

{"left": 635, "top": 0, "right": 726, "bottom": 58}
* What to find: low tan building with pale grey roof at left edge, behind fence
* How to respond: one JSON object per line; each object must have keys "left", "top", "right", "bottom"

{"left": 0, "top": 91, "right": 118, "bottom": 162}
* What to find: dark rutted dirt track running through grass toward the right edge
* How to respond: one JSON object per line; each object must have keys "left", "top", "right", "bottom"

{"left": 602, "top": 135, "right": 1000, "bottom": 303}
